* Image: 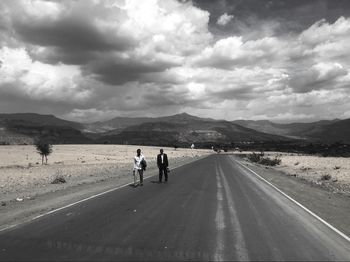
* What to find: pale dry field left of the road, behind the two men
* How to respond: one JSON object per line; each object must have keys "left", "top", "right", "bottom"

{"left": 0, "top": 145, "right": 210, "bottom": 204}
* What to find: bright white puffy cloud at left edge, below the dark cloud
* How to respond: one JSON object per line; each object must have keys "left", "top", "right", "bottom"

{"left": 0, "top": 47, "right": 90, "bottom": 101}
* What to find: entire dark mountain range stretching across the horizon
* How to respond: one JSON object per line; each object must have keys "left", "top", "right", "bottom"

{"left": 0, "top": 113, "right": 350, "bottom": 147}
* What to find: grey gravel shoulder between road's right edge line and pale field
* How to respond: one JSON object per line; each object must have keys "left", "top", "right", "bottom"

{"left": 235, "top": 156, "right": 350, "bottom": 236}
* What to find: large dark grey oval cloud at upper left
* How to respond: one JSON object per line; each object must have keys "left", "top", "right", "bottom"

{"left": 13, "top": 10, "right": 136, "bottom": 65}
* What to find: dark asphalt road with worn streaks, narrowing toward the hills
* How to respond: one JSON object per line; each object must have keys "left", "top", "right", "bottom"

{"left": 0, "top": 155, "right": 350, "bottom": 261}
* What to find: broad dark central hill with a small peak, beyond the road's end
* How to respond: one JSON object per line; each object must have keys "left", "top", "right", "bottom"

{"left": 98, "top": 114, "right": 290, "bottom": 146}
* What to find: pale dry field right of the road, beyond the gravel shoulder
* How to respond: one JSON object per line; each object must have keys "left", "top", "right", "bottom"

{"left": 243, "top": 152, "right": 350, "bottom": 195}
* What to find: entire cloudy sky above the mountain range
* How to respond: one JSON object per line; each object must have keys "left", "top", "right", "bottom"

{"left": 0, "top": 0, "right": 350, "bottom": 122}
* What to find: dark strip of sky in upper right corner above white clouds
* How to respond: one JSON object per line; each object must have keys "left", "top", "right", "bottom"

{"left": 193, "top": 0, "right": 350, "bottom": 35}
